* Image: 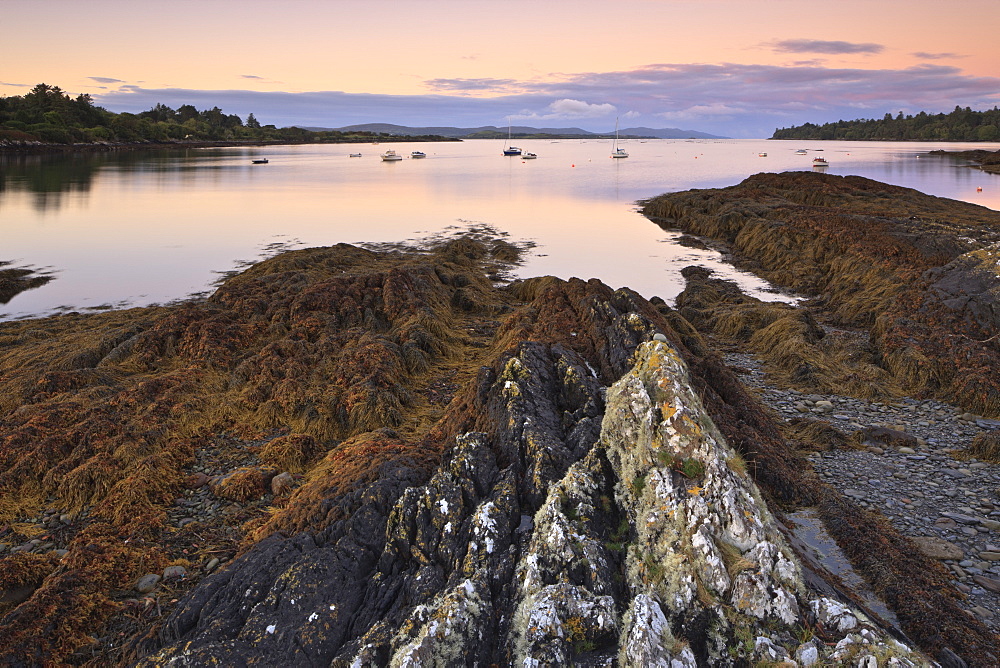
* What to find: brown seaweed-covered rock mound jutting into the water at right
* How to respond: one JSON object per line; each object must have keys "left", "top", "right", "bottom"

{"left": 643, "top": 172, "right": 1000, "bottom": 416}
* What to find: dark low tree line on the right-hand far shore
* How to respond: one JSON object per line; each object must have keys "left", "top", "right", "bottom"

{"left": 771, "top": 106, "right": 1000, "bottom": 141}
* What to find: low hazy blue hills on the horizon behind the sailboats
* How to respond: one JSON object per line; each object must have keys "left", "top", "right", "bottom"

{"left": 302, "top": 123, "right": 728, "bottom": 139}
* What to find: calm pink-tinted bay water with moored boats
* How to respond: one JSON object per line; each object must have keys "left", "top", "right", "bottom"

{"left": 0, "top": 140, "right": 1000, "bottom": 319}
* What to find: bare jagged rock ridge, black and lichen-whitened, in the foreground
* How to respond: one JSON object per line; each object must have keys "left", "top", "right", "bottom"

{"left": 144, "top": 342, "right": 928, "bottom": 666}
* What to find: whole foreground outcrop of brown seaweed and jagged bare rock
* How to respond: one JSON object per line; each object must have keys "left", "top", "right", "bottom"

{"left": 0, "top": 232, "right": 996, "bottom": 666}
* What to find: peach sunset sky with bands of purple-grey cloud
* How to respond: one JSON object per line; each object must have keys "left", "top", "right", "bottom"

{"left": 0, "top": 0, "right": 1000, "bottom": 138}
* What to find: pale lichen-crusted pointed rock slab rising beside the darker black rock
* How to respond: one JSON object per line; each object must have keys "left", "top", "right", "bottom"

{"left": 601, "top": 342, "right": 921, "bottom": 665}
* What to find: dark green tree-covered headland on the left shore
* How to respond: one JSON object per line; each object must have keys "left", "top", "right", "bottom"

{"left": 0, "top": 83, "right": 449, "bottom": 146}
